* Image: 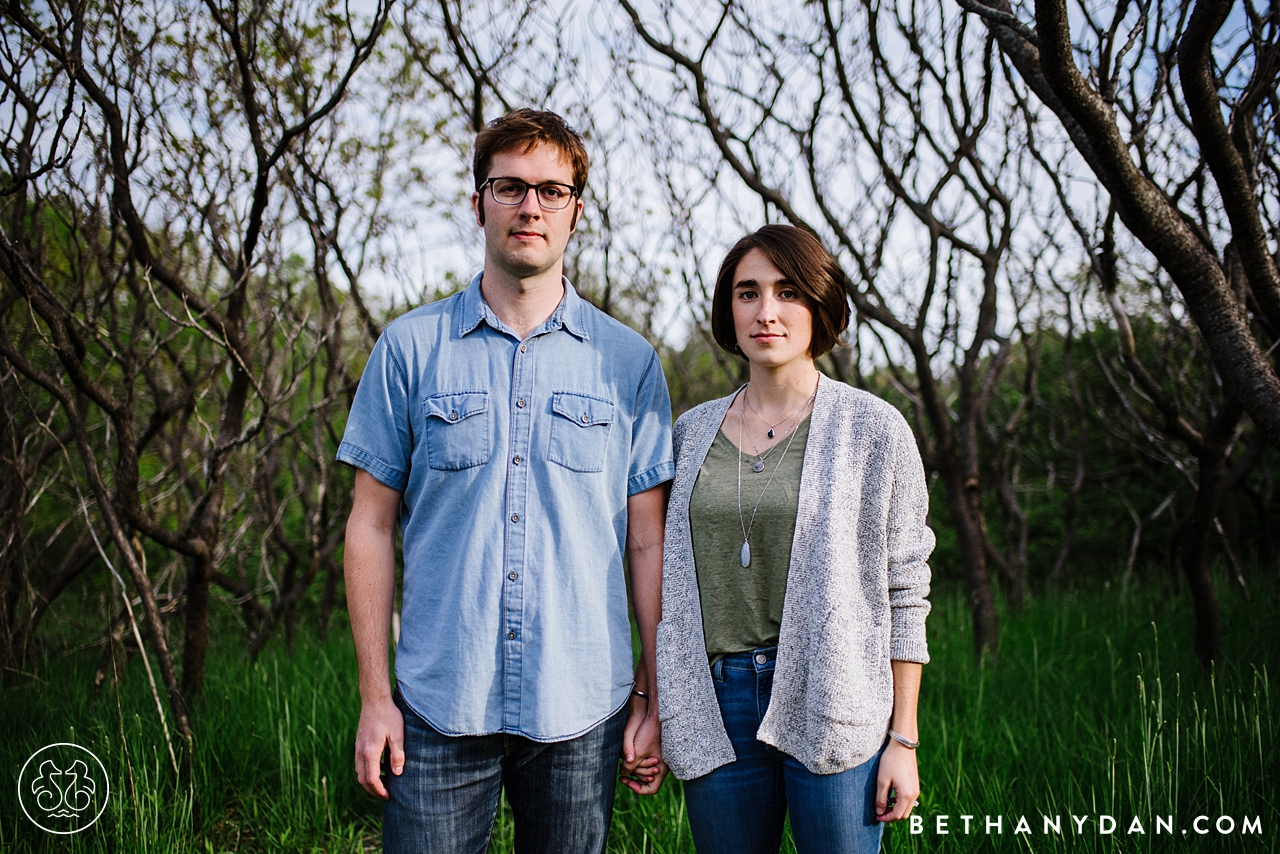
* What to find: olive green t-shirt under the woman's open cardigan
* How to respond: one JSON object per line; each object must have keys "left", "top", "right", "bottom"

{"left": 689, "top": 417, "right": 809, "bottom": 662}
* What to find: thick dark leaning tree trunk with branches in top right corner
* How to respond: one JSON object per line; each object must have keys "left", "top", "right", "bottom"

{"left": 959, "top": 0, "right": 1280, "bottom": 447}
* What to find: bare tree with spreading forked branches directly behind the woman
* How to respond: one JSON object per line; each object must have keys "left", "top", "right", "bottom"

{"left": 620, "top": 0, "right": 1075, "bottom": 650}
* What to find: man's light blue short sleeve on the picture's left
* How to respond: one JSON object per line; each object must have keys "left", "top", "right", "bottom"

{"left": 338, "top": 330, "right": 413, "bottom": 492}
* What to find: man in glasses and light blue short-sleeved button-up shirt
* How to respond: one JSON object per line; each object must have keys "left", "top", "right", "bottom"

{"left": 338, "top": 110, "right": 675, "bottom": 854}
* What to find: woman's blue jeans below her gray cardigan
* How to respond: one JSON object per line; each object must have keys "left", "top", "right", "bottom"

{"left": 685, "top": 647, "right": 883, "bottom": 854}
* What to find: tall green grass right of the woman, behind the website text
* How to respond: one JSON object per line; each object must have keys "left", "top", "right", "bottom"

{"left": 887, "top": 589, "right": 1280, "bottom": 851}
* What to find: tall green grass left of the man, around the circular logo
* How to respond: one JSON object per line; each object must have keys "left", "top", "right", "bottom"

{"left": 0, "top": 631, "right": 378, "bottom": 853}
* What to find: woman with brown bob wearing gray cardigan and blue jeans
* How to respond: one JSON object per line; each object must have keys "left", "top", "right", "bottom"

{"left": 658, "top": 225, "right": 933, "bottom": 854}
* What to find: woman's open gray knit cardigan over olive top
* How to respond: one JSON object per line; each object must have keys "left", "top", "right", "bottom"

{"left": 658, "top": 376, "right": 933, "bottom": 780}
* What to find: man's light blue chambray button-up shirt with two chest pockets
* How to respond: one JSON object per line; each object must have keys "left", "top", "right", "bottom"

{"left": 338, "top": 275, "right": 676, "bottom": 741}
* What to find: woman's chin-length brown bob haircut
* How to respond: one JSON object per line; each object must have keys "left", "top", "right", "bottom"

{"left": 712, "top": 225, "right": 849, "bottom": 359}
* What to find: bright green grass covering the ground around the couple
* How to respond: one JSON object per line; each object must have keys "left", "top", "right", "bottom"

{"left": 0, "top": 585, "right": 1280, "bottom": 853}
